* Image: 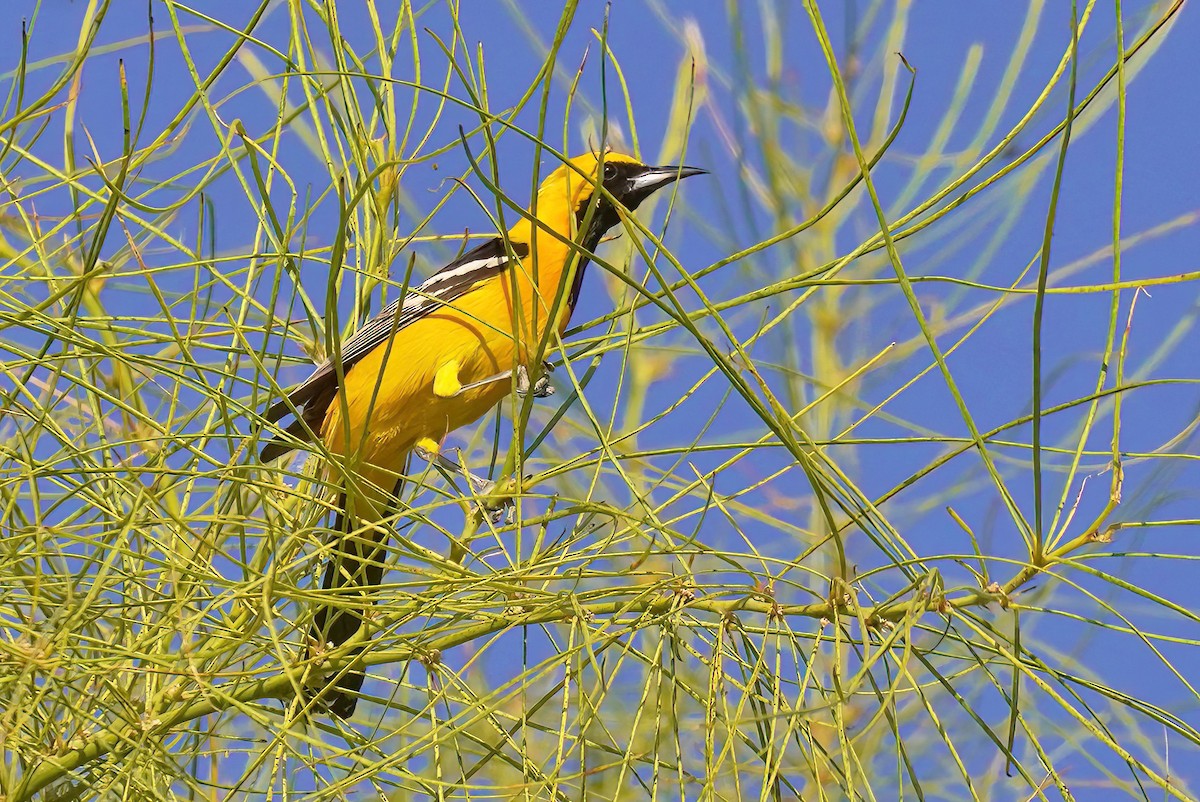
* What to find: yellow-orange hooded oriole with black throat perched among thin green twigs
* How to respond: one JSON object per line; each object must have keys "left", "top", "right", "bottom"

{"left": 262, "top": 152, "right": 704, "bottom": 717}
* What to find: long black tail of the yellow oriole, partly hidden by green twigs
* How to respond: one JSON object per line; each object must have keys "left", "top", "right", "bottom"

{"left": 310, "top": 493, "right": 386, "bottom": 718}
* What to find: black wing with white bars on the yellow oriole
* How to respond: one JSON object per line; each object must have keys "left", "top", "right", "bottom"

{"left": 263, "top": 237, "right": 529, "bottom": 461}
